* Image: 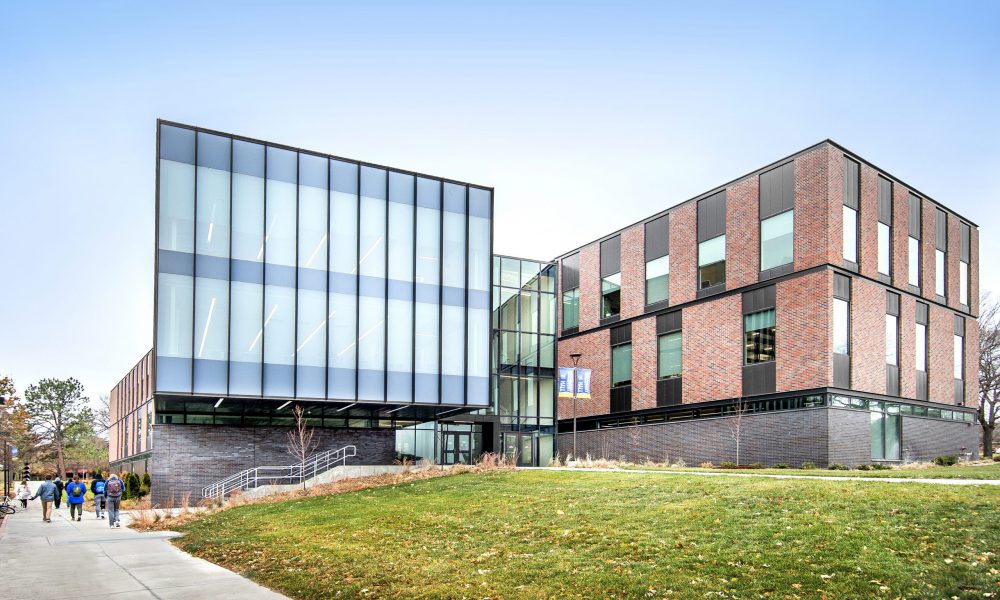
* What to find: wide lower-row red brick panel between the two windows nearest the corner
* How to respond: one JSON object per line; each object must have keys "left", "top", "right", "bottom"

{"left": 681, "top": 294, "right": 743, "bottom": 404}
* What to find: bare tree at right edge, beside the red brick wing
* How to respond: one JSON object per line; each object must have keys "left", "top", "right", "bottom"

{"left": 977, "top": 293, "right": 1000, "bottom": 457}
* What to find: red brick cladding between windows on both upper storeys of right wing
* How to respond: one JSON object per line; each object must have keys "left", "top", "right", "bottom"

{"left": 559, "top": 143, "right": 979, "bottom": 418}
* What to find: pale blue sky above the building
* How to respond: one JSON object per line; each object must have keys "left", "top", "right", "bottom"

{"left": 0, "top": 1, "right": 1000, "bottom": 397}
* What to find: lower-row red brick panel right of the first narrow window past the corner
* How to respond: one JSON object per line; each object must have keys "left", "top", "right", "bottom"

{"left": 851, "top": 277, "right": 885, "bottom": 394}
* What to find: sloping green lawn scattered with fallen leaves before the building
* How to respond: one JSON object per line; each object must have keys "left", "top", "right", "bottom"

{"left": 176, "top": 471, "right": 1000, "bottom": 598}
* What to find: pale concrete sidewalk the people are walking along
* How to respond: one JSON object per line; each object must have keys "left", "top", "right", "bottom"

{"left": 0, "top": 500, "right": 285, "bottom": 600}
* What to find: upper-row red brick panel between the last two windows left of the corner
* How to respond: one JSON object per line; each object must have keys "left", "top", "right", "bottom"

{"left": 726, "top": 177, "right": 760, "bottom": 290}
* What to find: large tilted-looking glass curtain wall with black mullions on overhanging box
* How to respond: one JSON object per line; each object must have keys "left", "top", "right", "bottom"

{"left": 155, "top": 123, "right": 492, "bottom": 407}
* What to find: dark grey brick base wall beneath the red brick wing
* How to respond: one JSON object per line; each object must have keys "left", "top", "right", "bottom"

{"left": 558, "top": 408, "right": 979, "bottom": 468}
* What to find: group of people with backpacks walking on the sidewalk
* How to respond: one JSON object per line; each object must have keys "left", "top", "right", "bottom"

{"left": 17, "top": 473, "right": 125, "bottom": 527}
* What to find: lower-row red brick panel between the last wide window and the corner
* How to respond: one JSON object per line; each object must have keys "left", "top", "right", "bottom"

{"left": 775, "top": 271, "right": 833, "bottom": 392}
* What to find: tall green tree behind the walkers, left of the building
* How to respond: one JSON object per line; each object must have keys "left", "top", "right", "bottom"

{"left": 24, "top": 377, "right": 93, "bottom": 476}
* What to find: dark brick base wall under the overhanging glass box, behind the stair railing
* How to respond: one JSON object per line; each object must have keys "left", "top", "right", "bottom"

{"left": 149, "top": 424, "right": 396, "bottom": 504}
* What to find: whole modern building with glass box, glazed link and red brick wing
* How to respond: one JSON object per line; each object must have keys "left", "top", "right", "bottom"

{"left": 110, "top": 121, "right": 978, "bottom": 500}
